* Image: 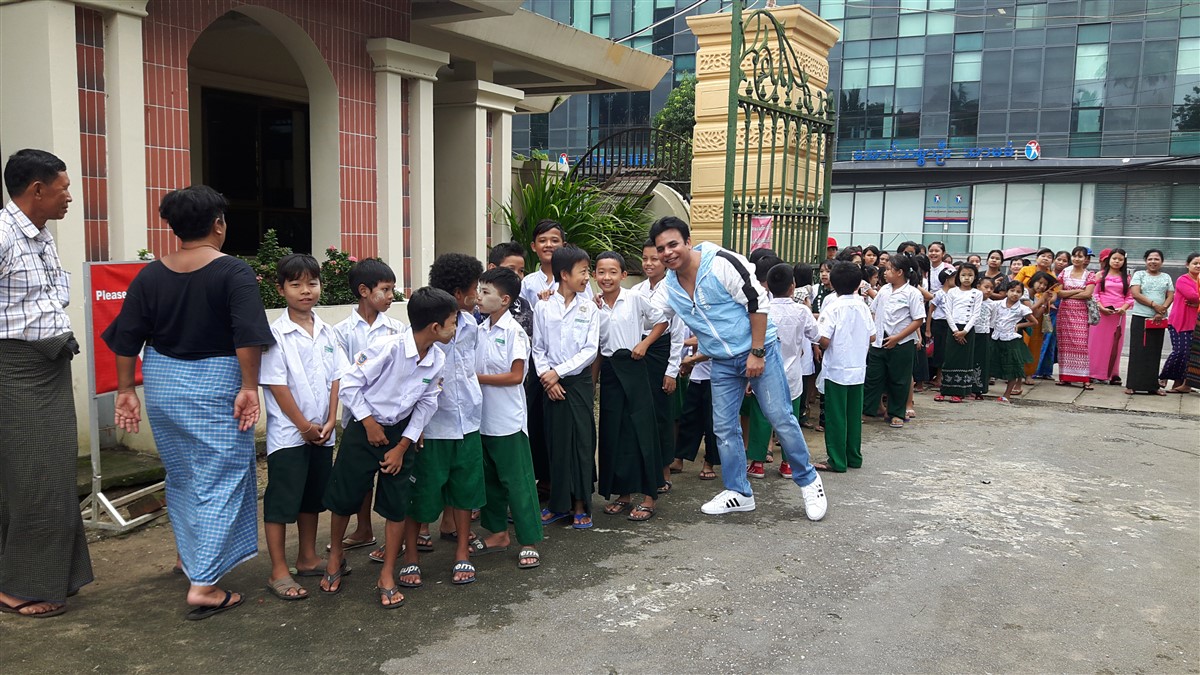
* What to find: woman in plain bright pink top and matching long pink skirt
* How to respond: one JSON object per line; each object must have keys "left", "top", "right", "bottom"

{"left": 1087, "top": 249, "right": 1133, "bottom": 387}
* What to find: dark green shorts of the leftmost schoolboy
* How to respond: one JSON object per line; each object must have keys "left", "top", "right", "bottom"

{"left": 263, "top": 444, "right": 334, "bottom": 522}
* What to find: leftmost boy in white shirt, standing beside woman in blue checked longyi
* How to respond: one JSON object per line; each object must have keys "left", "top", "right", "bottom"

{"left": 258, "top": 253, "right": 346, "bottom": 601}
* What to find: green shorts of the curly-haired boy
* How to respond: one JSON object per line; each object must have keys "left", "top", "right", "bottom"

{"left": 408, "top": 431, "right": 487, "bottom": 522}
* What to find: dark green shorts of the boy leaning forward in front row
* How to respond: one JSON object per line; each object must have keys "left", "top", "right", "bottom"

{"left": 325, "top": 418, "right": 420, "bottom": 522}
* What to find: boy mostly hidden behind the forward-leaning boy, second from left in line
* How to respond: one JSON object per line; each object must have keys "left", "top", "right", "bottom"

{"left": 325, "top": 258, "right": 404, "bottom": 552}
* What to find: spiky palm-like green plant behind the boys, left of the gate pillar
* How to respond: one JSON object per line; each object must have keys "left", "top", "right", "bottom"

{"left": 499, "top": 164, "right": 650, "bottom": 271}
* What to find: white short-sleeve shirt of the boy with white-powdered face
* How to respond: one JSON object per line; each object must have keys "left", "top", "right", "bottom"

{"left": 475, "top": 312, "right": 530, "bottom": 436}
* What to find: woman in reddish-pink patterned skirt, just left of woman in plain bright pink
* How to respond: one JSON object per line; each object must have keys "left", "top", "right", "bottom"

{"left": 1055, "top": 246, "right": 1096, "bottom": 389}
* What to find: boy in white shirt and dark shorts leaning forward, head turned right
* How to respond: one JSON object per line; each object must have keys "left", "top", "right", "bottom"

{"left": 320, "top": 287, "right": 458, "bottom": 609}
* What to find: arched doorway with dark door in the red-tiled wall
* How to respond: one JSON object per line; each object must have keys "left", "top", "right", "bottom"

{"left": 187, "top": 6, "right": 340, "bottom": 255}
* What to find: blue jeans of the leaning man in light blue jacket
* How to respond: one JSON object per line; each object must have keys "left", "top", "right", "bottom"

{"left": 712, "top": 341, "right": 817, "bottom": 497}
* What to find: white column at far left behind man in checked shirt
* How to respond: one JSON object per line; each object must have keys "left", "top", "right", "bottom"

{"left": 0, "top": 0, "right": 91, "bottom": 452}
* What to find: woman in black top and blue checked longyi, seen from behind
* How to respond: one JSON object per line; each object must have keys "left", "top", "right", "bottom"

{"left": 103, "top": 185, "right": 275, "bottom": 620}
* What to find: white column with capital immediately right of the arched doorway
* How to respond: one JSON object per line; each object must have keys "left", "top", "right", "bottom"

{"left": 367, "top": 37, "right": 450, "bottom": 288}
